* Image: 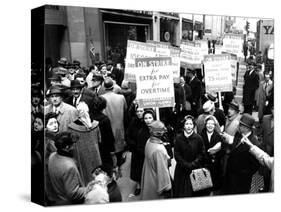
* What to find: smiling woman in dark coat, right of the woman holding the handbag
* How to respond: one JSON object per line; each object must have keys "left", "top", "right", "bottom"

{"left": 201, "top": 116, "right": 223, "bottom": 193}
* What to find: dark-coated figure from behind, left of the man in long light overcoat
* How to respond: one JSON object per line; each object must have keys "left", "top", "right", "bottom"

{"left": 92, "top": 96, "right": 116, "bottom": 167}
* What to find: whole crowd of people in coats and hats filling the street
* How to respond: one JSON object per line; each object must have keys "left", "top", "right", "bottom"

{"left": 31, "top": 54, "right": 274, "bottom": 205}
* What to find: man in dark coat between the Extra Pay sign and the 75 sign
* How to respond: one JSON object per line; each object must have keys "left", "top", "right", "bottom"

{"left": 187, "top": 69, "right": 202, "bottom": 117}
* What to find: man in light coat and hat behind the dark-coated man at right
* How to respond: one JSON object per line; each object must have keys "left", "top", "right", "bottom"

{"left": 224, "top": 101, "right": 241, "bottom": 136}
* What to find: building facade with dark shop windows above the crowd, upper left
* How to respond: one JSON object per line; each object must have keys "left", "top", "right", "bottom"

{"left": 32, "top": 5, "right": 203, "bottom": 69}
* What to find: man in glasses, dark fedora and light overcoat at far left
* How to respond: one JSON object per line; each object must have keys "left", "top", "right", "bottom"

{"left": 45, "top": 86, "right": 78, "bottom": 132}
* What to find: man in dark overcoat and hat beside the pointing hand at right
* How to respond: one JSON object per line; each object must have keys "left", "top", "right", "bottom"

{"left": 221, "top": 113, "right": 259, "bottom": 194}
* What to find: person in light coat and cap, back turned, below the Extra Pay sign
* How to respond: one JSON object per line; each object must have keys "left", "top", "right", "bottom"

{"left": 140, "top": 121, "right": 172, "bottom": 200}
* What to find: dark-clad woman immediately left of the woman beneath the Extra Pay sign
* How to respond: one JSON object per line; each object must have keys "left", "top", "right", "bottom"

{"left": 126, "top": 105, "right": 146, "bottom": 193}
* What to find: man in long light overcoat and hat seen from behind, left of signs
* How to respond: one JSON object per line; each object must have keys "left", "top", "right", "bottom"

{"left": 101, "top": 77, "right": 127, "bottom": 172}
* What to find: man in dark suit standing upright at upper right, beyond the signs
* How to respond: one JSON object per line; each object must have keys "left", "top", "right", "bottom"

{"left": 243, "top": 61, "right": 259, "bottom": 114}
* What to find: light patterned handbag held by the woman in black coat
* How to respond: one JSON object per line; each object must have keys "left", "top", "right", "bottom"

{"left": 189, "top": 168, "right": 213, "bottom": 191}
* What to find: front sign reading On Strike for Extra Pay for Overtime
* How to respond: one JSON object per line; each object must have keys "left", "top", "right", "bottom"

{"left": 135, "top": 57, "right": 175, "bottom": 108}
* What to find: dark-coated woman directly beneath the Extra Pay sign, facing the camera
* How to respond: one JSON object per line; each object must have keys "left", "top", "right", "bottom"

{"left": 131, "top": 109, "right": 156, "bottom": 195}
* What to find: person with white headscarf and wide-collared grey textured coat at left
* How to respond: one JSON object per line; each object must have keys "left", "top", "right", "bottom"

{"left": 68, "top": 102, "right": 101, "bottom": 185}
